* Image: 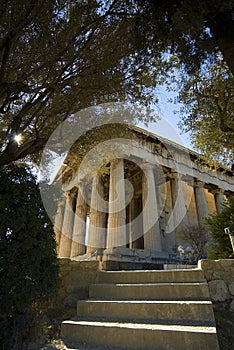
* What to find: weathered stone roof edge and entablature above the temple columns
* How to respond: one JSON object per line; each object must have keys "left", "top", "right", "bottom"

{"left": 53, "top": 124, "right": 234, "bottom": 191}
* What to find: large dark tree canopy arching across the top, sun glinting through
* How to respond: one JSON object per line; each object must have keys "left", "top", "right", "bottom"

{"left": 0, "top": 0, "right": 234, "bottom": 165}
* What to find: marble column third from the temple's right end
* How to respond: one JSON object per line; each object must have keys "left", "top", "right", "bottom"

{"left": 170, "top": 173, "right": 188, "bottom": 234}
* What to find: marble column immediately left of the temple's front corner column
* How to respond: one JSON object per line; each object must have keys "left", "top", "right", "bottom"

{"left": 87, "top": 174, "right": 106, "bottom": 254}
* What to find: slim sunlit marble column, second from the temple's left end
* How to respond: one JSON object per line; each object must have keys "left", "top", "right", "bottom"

{"left": 59, "top": 193, "right": 75, "bottom": 258}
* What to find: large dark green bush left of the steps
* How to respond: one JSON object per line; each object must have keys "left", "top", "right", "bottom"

{"left": 0, "top": 165, "right": 58, "bottom": 350}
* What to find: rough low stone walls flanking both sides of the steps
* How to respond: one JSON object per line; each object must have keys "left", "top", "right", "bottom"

{"left": 53, "top": 258, "right": 234, "bottom": 350}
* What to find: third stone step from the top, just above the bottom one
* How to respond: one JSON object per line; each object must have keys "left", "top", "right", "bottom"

{"left": 77, "top": 300, "right": 215, "bottom": 326}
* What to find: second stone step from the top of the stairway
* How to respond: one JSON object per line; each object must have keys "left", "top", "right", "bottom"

{"left": 89, "top": 282, "right": 210, "bottom": 300}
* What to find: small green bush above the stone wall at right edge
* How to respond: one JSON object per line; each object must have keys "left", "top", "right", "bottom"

{"left": 206, "top": 197, "right": 234, "bottom": 259}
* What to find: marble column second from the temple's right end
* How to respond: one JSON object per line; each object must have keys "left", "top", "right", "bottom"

{"left": 193, "top": 181, "right": 209, "bottom": 226}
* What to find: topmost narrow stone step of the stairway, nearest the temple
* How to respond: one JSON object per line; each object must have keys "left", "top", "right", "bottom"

{"left": 97, "top": 269, "right": 205, "bottom": 283}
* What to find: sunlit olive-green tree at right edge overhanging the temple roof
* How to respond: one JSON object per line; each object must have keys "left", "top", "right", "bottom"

{"left": 177, "top": 61, "right": 234, "bottom": 168}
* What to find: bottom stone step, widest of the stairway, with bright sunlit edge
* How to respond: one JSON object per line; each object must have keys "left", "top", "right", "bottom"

{"left": 61, "top": 321, "right": 219, "bottom": 350}
